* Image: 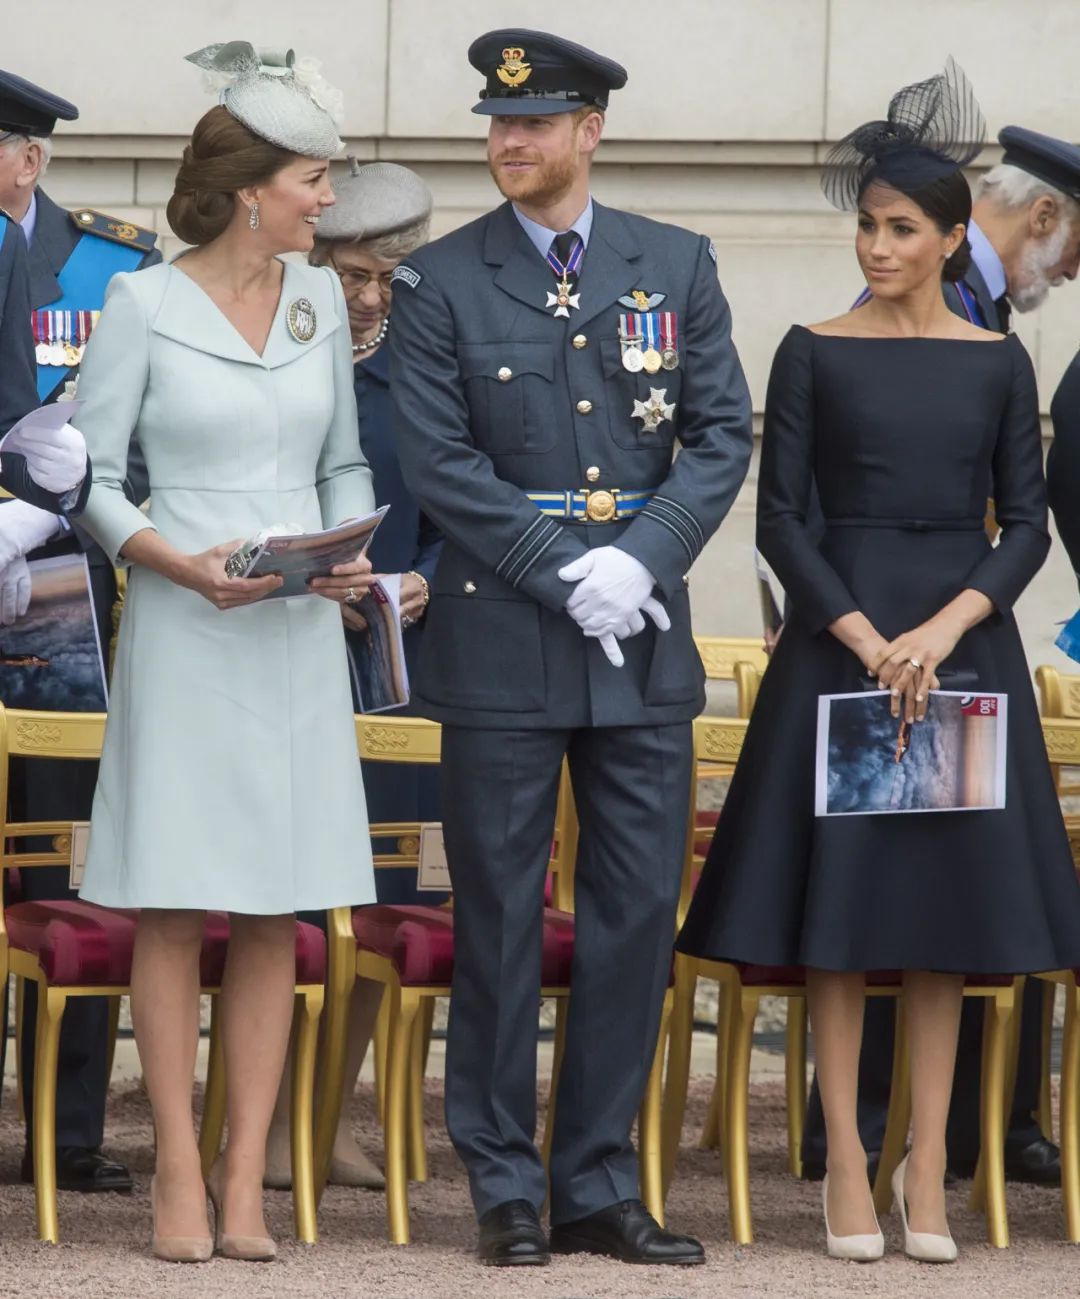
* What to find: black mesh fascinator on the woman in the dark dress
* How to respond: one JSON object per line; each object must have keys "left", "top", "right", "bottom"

{"left": 821, "top": 56, "right": 986, "bottom": 212}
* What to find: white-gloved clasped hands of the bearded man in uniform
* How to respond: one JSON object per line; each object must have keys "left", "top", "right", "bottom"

{"left": 559, "top": 546, "right": 671, "bottom": 668}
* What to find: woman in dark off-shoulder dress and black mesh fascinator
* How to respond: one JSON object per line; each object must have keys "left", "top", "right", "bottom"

{"left": 677, "top": 61, "right": 1080, "bottom": 1261}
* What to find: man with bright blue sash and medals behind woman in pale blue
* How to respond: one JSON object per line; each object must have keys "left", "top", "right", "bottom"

{"left": 0, "top": 71, "right": 161, "bottom": 1191}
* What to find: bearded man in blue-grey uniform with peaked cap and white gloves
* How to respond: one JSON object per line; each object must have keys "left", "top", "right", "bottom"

{"left": 390, "top": 30, "right": 751, "bottom": 1264}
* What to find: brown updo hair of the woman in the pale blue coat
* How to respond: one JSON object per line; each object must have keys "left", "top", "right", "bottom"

{"left": 165, "top": 104, "right": 294, "bottom": 246}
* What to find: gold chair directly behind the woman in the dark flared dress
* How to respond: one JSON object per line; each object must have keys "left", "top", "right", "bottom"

{"left": 664, "top": 717, "right": 1023, "bottom": 1247}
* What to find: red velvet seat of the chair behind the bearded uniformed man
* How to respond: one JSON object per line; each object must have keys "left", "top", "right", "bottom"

{"left": 352, "top": 904, "right": 573, "bottom": 987}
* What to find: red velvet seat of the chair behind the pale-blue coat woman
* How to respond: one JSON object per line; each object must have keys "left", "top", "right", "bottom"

{"left": 4, "top": 899, "right": 326, "bottom": 987}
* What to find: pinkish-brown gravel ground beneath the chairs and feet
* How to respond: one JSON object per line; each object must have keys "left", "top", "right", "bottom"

{"left": 0, "top": 1079, "right": 1080, "bottom": 1299}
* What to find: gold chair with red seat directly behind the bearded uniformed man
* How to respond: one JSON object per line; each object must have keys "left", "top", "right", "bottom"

{"left": 315, "top": 716, "right": 669, "bottom": 1244}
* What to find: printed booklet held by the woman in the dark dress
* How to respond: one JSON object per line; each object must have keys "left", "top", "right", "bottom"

{"left": 815, "top": 690, "right": 1009, "bottom": 816}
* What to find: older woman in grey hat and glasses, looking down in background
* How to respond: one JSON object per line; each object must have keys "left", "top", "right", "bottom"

{"left": 266, "top": 158, "right": 442, "bottom": 1190}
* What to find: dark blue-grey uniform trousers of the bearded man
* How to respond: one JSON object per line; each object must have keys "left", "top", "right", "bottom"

{"left": 441, "top": 724, "right": 691, "bottom": 1224}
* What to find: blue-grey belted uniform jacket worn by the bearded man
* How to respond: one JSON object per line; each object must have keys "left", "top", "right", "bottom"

{"left": 390, "top": 204, "right": 751, "bottom": 729}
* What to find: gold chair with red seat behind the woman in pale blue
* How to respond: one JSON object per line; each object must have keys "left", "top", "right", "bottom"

{"left": 0, "top": 704, "right": 325, "bottom": 1244}
